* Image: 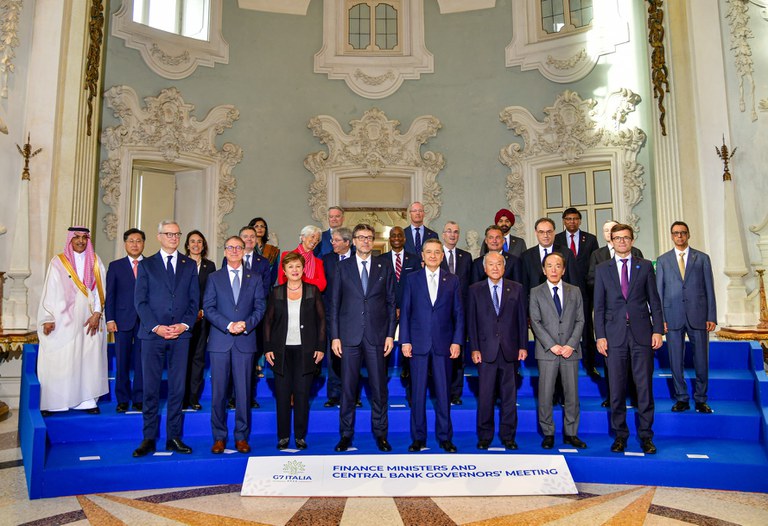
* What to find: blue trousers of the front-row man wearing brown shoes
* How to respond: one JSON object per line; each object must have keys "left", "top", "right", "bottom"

{"left": 208, "top": 349, "right": 255, "bottom": 442}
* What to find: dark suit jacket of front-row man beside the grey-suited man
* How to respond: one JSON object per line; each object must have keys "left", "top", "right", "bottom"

{"left": 467, "top": 279, "right": 528, "bottom": 362}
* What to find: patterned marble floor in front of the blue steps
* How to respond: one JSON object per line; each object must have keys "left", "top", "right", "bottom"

{"left": 0, "top": 413, "right": 768, "bottom": 526}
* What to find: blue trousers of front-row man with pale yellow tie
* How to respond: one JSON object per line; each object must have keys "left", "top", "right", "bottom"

{"left": 411, "top": 353, "right": 453, "bottom": 442}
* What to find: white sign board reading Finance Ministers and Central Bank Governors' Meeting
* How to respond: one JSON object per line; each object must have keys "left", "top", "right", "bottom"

{"left": 241, "top": 455, "right": 578, "bottom": 497}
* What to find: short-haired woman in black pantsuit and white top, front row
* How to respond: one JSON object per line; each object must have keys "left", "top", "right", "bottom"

{"left": 264, "top": 254, "right": 325, "bottom": 449}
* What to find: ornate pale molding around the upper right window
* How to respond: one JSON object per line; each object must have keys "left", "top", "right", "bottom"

{"left": 506, "top": 0, "right": 629, "bottom": 83}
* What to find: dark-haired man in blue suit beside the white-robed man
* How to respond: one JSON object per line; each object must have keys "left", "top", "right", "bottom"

{"left": 104, "top": 228, "right": 146, "bottom": 413}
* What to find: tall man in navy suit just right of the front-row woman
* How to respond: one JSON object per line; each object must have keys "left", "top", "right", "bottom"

{"left": 330, "top": 224, "right": 397, "bottom": 451}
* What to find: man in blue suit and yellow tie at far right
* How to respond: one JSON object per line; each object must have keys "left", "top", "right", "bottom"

{"left": 656, "top": 221, "right": 717, "bottom": 414}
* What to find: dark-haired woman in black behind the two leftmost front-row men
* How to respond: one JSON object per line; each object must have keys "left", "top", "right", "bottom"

{"left": 183, "top": 230, "right": 216, "bottom": 411}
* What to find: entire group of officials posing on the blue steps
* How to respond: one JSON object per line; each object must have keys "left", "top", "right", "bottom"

{"left": 38, "top": 202, "right": 716, "bottom": 457}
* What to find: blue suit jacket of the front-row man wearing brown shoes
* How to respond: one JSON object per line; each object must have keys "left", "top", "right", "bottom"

{"left": 203, "top": 265, "right": 267, "bottom": 353}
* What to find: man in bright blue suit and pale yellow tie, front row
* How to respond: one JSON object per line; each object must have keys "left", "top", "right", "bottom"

{"left": 400, "top": 239, "right": 464, "bottom": 453}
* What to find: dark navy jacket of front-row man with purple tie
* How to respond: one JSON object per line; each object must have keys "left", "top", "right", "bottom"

{"left": 594, "top": 257, "right": 664, "bottom": 347}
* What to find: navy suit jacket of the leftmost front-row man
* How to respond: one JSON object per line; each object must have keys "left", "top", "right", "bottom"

{"left": 136, "top": 251, "right": 200, "bottom": 341}
